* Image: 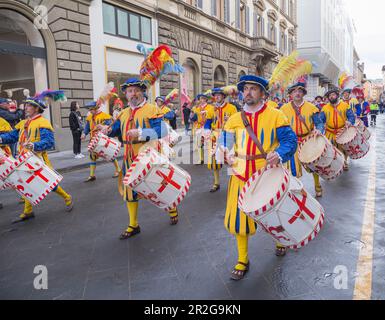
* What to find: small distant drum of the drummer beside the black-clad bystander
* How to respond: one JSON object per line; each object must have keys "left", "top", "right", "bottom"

{"left": 88, "top": 132, "right": 121, "bottom": 161}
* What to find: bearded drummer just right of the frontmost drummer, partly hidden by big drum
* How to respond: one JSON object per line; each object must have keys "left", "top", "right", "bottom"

{"left": 281, "top": 82, "right": 324, "bottom": 197}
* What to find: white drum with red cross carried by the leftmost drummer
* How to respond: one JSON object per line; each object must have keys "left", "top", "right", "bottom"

{"left": 0, "top": 152, "right": 63, "bottom": 205}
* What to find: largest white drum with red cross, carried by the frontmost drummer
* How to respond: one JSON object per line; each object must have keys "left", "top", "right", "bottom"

{"left": 238, "top": 166, "right": 325, "bottom": 249}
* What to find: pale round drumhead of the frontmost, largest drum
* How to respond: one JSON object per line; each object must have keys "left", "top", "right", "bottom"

{"left": 242, "top": 166, "right": 287, "bottom": 213}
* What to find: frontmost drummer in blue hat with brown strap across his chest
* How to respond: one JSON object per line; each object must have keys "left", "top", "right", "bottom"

{"left": 217, "top": 75, "right": 297, "bottom": 280}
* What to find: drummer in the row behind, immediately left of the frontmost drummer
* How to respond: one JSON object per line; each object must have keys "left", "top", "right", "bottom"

{"left": 207, "top": 88, "right": 238, "bottom": 193}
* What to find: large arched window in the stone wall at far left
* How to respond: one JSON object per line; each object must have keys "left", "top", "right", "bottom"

{"left": 0, "top": 9, "right": 50, "bottom": 118}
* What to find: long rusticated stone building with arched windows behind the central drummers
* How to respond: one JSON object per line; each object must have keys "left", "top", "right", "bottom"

{"left": 157, "top": 0, "right": 297, "bottom": 97}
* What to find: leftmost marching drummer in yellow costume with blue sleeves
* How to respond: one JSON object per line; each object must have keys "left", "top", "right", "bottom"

{"left": 0, "top": 98, "right": 73, "bottom": 222}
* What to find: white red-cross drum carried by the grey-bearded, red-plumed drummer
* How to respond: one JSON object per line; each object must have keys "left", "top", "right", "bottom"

{"left": 123, "top": 147, "right": 191, "bottom": 211}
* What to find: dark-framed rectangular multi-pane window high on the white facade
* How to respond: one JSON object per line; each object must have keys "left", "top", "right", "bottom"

{"left": 103, "top": 3, "right": 152, "bottom": 44}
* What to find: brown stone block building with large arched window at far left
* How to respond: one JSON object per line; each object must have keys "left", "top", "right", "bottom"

{"left": 0, "top": 0, "right": 93, "bottom": 150}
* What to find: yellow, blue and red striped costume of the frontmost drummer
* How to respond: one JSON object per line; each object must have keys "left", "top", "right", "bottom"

{"left": 220, "top": 104, "right": 297, "bottom": 236}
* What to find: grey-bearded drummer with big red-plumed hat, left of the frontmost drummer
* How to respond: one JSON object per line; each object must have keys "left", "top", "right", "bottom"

{"left": 98, "top": 78, "right": 178, "bottom": 240}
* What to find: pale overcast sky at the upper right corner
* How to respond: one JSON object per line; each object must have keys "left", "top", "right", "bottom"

{"left": 345, "top": 0, "right": 385, "bottom": 79}
